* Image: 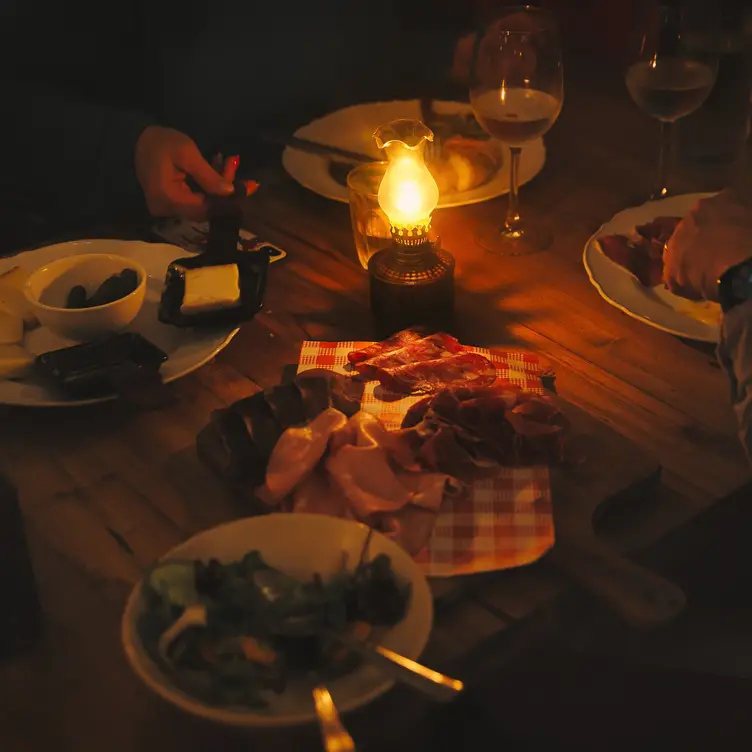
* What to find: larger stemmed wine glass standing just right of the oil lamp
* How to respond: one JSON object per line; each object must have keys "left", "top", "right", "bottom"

{"left": 470, "top": 5, "right": 564, "bottom": 256}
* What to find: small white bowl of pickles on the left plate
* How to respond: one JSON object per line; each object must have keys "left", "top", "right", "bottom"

{"left": 24, "top": 253, "right": 146, "bottom": 342}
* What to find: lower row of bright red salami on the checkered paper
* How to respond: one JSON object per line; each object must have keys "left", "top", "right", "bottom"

{"left": 376, "top": 352, "right": 496, "bottom": 394}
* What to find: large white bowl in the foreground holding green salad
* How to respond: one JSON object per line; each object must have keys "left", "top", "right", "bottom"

{"left": 122, "top": 514, "right": 433, "bottom": 727}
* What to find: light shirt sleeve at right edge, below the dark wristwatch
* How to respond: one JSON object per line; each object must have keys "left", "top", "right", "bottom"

{"left": 718, "top": 301, "right": 752, "bottom": 462}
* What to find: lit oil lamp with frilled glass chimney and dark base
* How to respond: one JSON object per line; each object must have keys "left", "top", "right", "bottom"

{"left": 368, "top": 120, "right": 454, "bottom": 337}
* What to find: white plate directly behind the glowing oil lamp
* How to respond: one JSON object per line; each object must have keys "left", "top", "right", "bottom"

{"left": 282, "top": 99, "right": 546, "bottom": 209}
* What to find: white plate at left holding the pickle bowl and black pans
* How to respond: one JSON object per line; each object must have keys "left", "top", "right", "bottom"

{"left": 0, "top": 240, "right": 238, "bottom": 407}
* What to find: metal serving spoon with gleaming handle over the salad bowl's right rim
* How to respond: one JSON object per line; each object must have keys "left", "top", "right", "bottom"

{"left": 253, "top": 569, "right": 464, "bottom": 702}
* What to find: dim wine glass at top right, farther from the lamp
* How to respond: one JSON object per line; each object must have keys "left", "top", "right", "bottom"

{"left": 626, "top": 3, "right": 718, "bottom": 200}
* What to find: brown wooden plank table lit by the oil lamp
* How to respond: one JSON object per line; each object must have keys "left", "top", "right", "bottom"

{"left": 0, "top": 55, "right": 748, "bottom": 752}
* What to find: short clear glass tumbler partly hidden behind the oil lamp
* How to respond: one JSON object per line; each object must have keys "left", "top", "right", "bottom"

{"left": 347, "top": 162, "right": 392, "bottom": 269}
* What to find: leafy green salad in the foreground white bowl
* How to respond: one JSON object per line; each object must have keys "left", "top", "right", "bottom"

{"left": 138, "top": 551, "right": 410, "bottom": 708}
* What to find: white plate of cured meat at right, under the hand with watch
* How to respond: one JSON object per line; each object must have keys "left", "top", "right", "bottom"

{"left": 583, "top": 193, "right": 721, "bottom": 342}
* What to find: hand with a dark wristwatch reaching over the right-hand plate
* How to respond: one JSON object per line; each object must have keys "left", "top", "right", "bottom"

{"left": 663, "top": 191, "right": 752, "bottom": 301}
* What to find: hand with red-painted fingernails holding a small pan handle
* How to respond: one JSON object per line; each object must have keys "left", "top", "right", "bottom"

{"left": 135, "top": 125, "right": 237, "bottom": 222}
